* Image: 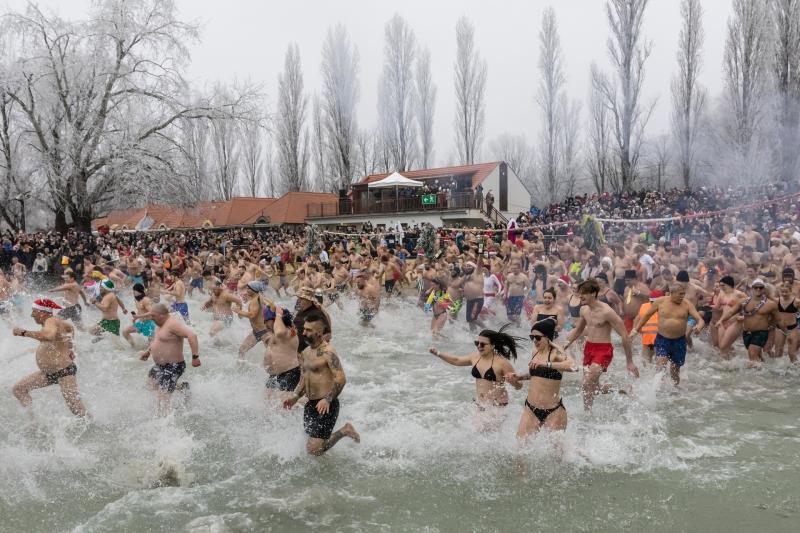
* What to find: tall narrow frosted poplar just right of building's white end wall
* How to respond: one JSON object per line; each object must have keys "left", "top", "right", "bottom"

{"left": 536, "top": 7, "right": 566, "bottom": 204}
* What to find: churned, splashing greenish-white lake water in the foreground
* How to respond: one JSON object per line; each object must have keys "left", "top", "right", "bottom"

{"left": 0, "top": 297, "right": 800, "bottom": 532}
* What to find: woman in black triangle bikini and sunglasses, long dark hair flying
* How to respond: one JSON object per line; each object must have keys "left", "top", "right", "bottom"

{"left": 430, "top": 325, "right": 522, "bottom": 411}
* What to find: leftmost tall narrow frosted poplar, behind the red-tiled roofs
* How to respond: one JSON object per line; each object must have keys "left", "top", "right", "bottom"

{"left": 275, "top": 44, "right": 309, "bottom": 191}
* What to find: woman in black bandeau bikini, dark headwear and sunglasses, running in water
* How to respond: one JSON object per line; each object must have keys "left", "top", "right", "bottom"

{"left": 506, "top": 318, "right": 577, "bottom": 438}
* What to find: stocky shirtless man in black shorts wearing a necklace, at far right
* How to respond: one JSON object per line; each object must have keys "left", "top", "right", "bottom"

{"left": 717, "top": 278, "right": 789, "bottom": 367}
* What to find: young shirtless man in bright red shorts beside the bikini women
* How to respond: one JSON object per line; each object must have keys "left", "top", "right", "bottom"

{"left": 564, "top": 279, "right": 639, "bottom": 410}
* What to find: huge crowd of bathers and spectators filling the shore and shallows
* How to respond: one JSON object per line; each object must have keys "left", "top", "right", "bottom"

{"left": 0, "top": 186, "right": 800, "bottom": 455}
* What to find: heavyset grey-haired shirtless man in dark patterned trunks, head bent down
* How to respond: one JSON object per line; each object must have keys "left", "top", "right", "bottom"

{"left": 139, "top": 304, "right": 200, "bottom": 416}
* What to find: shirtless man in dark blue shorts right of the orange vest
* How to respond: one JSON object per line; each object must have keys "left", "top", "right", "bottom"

{"left": 631, "top": 282, "right": 705, "bottom": 387}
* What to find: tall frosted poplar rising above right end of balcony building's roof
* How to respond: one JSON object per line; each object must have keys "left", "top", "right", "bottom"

{"left": 454, "top": 17, "right": 486, "bottom": 165}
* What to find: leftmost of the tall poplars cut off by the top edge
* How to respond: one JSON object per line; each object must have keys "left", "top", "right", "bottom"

{"left": 592, "top": 0, "right": 655, "bottom": 190}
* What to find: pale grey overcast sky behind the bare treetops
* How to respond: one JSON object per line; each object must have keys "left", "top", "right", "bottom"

{"left": 7, "top": 0, "right": 731, "bottom": 164}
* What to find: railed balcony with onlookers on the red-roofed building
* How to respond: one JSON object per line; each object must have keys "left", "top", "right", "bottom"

{"left": 306, "top": 190, "right": 482, "bottom": 219}
